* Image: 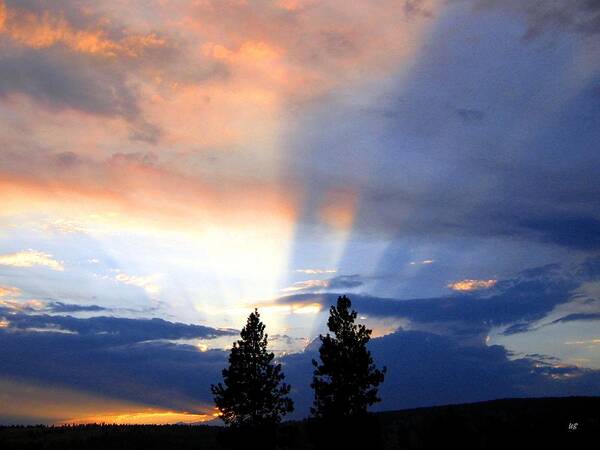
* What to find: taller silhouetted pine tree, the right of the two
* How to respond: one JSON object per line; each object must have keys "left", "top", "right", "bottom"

{"left": 311, "top": 296, "right": 385, "bottom": 418}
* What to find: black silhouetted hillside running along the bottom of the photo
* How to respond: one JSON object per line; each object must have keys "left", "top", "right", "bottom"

{"left": 0, "top": 397, "right": 600, "bottom": 450}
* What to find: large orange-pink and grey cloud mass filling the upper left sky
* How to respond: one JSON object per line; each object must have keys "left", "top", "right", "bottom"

{"left": 0, "top": 0, "right": 437, "bottom": 239}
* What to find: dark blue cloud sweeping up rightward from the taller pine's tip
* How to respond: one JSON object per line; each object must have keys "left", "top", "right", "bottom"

{"left": 279, "top": 259, "right": 598, "bottom": 338}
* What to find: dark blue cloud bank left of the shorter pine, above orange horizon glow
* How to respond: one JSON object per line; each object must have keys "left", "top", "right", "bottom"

{"left": 0, "top": 313, "right": 236, "bottom": 411}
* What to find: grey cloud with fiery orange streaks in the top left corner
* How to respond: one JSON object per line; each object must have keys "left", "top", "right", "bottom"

{"left": 0, "top": 1, "right": 176, "bottom": 144}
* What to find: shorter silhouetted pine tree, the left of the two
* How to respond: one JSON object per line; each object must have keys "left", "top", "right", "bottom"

{"left": 211, "top": 309, "right": 294, "bottom": 427}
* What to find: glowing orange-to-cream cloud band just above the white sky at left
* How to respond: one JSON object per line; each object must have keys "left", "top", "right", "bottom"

{"left": 0, "top": 153, "right": 298, "bottom": 236}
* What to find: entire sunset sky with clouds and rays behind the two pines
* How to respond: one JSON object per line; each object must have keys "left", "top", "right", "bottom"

{"left": 0, "top": 0, "right": 600, "bottom": 424}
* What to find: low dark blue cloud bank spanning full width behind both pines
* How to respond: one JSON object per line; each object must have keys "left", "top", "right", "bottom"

{"left": 0, "top": 314, "right": 600, "bottom": 418}
